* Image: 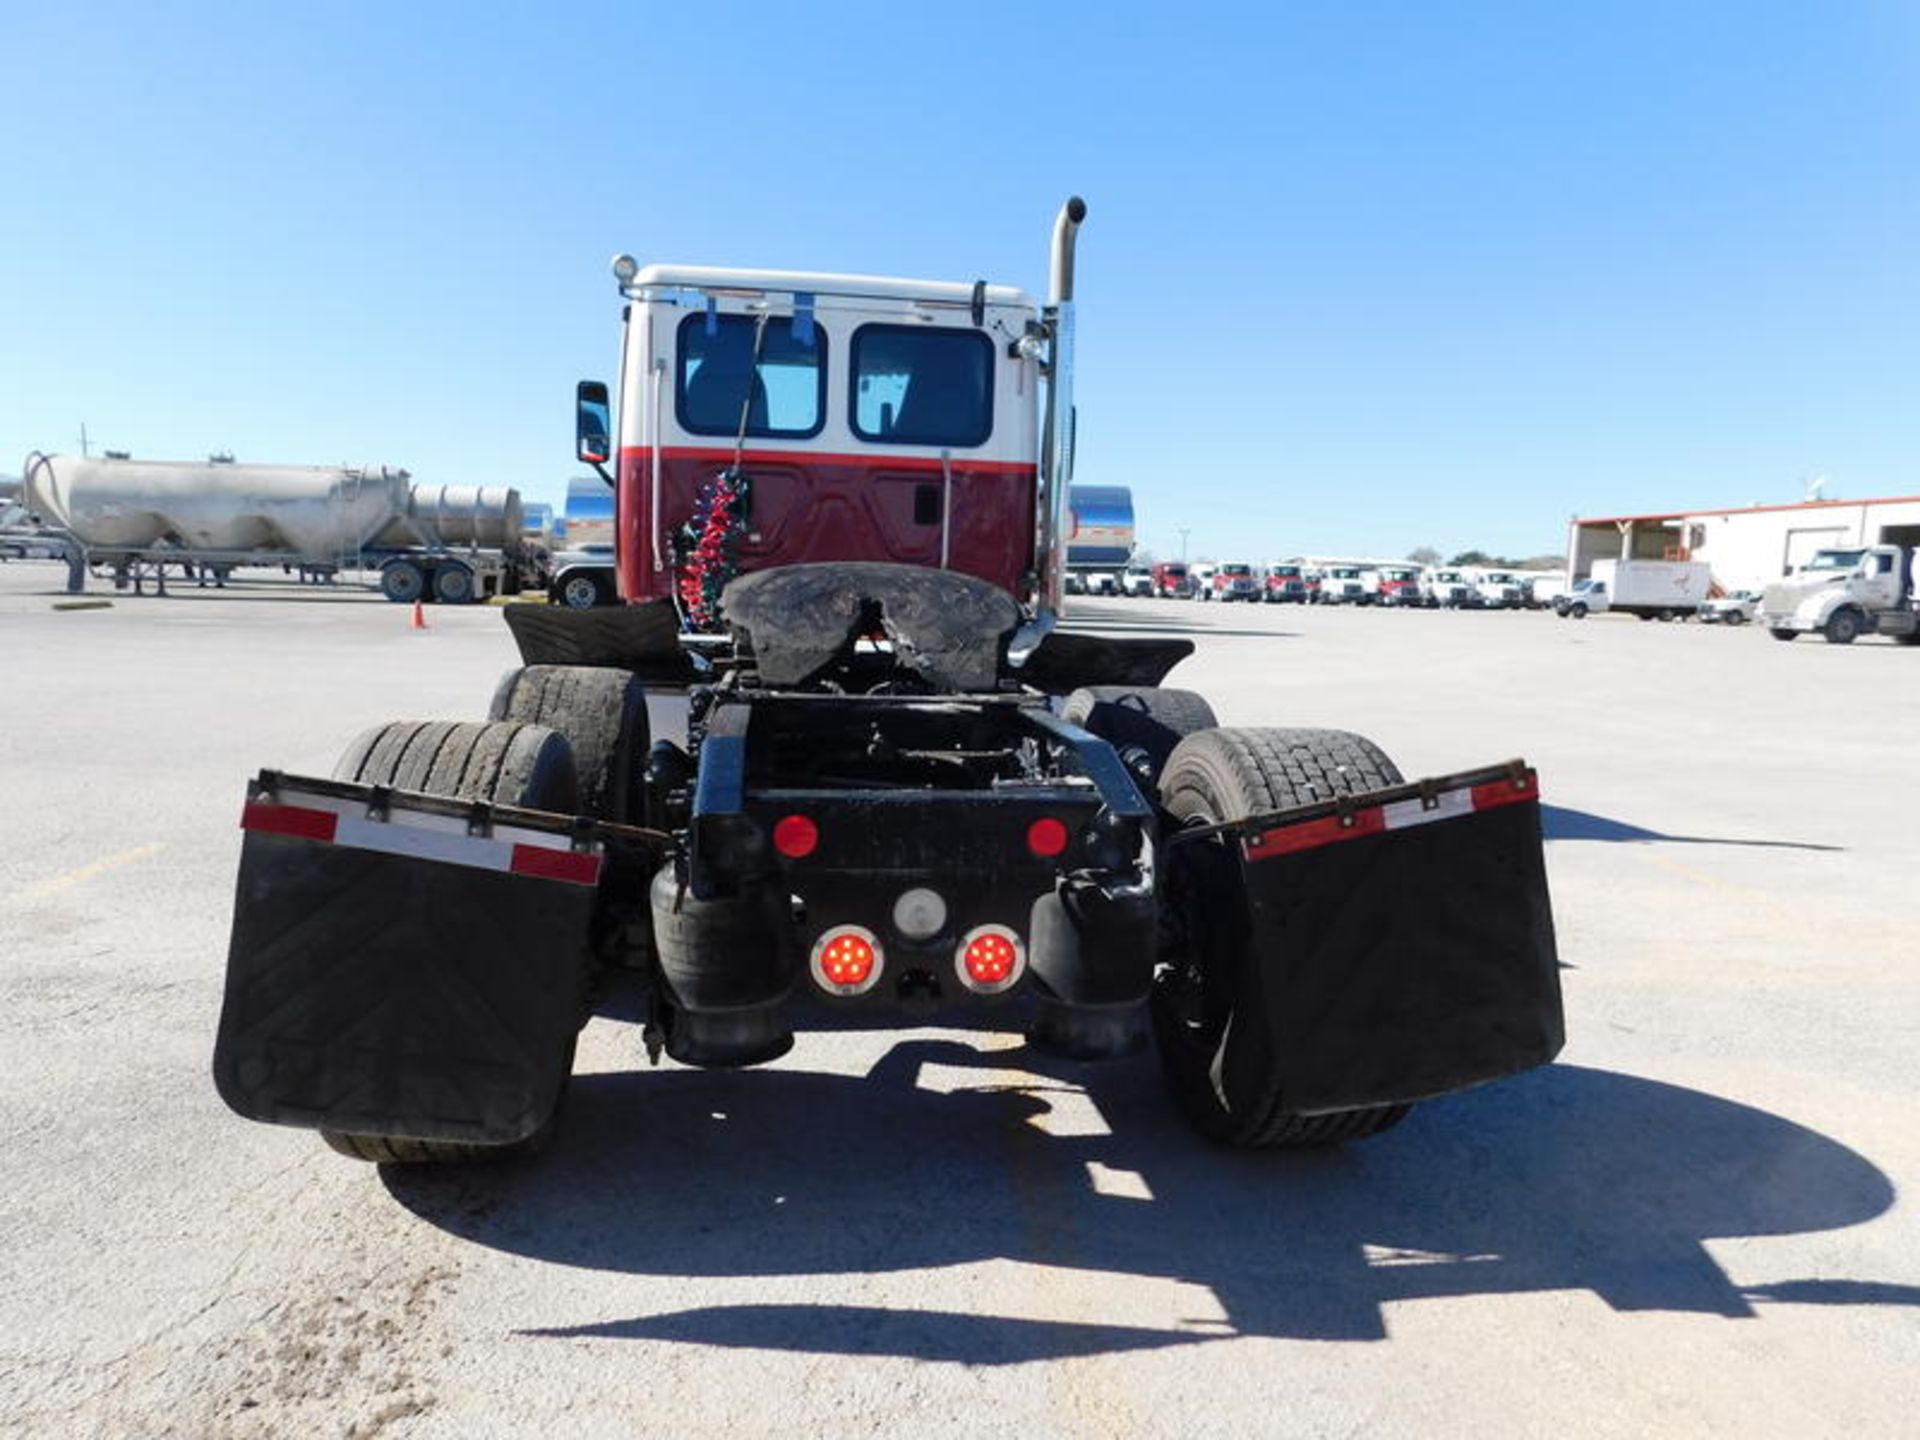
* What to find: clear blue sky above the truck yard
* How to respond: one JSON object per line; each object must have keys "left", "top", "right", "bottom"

{"left": 0, "top": 0, "right": 1920, "bottom": 559}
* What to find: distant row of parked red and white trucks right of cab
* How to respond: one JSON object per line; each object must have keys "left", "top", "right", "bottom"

{"left": 1116, "top": 559, "right": 1563, "bottom": 611}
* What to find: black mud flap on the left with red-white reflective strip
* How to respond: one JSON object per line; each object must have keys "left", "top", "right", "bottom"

{"left": 213, "top": 778, "right": 601, "bottom": 1144}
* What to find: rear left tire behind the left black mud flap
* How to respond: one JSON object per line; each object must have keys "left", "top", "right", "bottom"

{"left": 321, "top": 720, "right": 591, "bottom": 1165}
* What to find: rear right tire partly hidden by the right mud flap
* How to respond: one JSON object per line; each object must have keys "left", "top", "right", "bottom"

{"left": 1152, "top": 730, "right": 1411, "bottom": 1150}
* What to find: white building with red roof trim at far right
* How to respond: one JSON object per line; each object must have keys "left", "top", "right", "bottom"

{"left": 1567, "top": 495, "right": 1920, "bottom": 589}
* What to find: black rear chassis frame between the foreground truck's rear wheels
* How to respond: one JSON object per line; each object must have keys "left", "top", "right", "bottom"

{"left": 655, "top": 687, "right": 1154, "bottom": 1054}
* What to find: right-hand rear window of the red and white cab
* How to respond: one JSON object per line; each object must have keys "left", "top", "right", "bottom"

{"left": 847, "top": 324, "right": 993, "bottom": 445}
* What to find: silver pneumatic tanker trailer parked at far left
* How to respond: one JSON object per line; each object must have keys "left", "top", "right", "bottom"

{"left": 25, "top": 453, "right": 545, "bottom": 605}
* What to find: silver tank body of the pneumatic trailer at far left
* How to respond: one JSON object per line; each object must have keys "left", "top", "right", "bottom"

{"left": 25, "top": 455, "right": 413, "bottom": 561}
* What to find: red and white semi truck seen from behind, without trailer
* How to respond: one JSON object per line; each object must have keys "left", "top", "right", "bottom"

{"left": 213, "top": 200, "right": 1563, "bottom": 1162}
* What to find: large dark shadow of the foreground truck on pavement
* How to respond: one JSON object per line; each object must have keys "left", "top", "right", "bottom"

{"left": 382, "top": 1039, "right": 1920, "bottom": 1365}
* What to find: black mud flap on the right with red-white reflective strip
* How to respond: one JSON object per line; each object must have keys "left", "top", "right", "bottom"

{"left": 1215, "top": 764, "right": 1565, "bottom": 1116}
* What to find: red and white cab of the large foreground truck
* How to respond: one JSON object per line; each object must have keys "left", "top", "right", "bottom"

{"left": 580, "top": 257, "right": 1043, "bottom": 626}
